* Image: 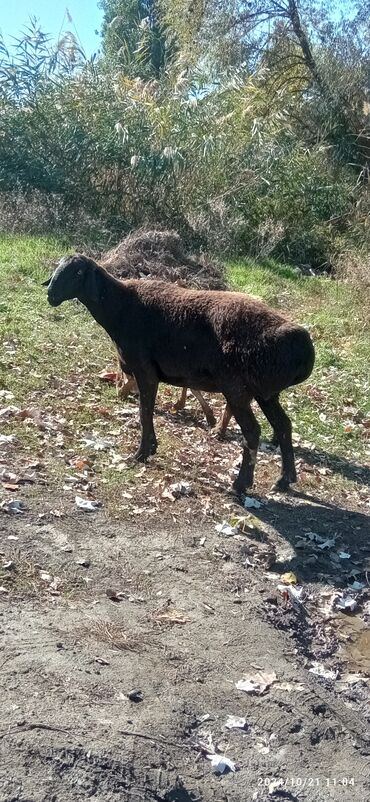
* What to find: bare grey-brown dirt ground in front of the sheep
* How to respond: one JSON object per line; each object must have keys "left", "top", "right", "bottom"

{"left": 0, "top": 450, "right": 370, "bottom": 802}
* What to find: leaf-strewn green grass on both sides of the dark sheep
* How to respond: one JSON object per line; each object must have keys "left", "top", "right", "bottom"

{"left": 0, "top": 235, "right": 370, "bottom": 506}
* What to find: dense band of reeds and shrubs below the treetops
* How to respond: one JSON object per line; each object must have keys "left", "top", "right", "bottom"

{"left": 0, "top": 10, "right": 369, "bottom": 267}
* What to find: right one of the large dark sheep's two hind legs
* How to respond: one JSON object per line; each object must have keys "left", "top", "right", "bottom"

{"left": 256, "top": 396, "right": 297, "bottom": 490}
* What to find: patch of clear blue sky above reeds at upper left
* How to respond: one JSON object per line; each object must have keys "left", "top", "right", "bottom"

{"left": 0, "top": 0, "right": 102, "bottom": 56}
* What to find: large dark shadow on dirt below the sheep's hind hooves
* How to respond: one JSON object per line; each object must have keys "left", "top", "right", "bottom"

{"left": 249, "top": 491, "right": 370, "bottom": 587}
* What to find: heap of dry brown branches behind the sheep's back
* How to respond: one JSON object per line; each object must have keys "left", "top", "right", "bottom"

{"left": 100, "top": 229, "right": 227, "bottom": 290}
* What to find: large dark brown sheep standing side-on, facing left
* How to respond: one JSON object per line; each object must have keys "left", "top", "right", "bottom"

{"left": 45, "top": 254, "right": 315, "bottom": 493}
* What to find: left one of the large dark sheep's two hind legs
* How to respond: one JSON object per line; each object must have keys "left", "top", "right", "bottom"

{"left": 225, "top": 394, "right": 261, "bottom": 495}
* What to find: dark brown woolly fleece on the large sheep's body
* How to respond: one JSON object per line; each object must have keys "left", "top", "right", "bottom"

{"left": 102, "top": 280, "right": 314, "bottom": 398}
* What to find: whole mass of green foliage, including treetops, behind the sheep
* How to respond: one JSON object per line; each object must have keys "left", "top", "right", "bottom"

{"left": 0, "top": 0, "right": 370, "bottom": 267}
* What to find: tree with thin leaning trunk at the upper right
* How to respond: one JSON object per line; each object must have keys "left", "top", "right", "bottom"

{"left": 160, "top": 0, "right": 370, "bottom": 168}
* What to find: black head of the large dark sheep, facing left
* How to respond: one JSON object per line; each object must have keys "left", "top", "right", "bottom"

{"left": 43, "top": 253, "right": 96, "bottom": 306}
